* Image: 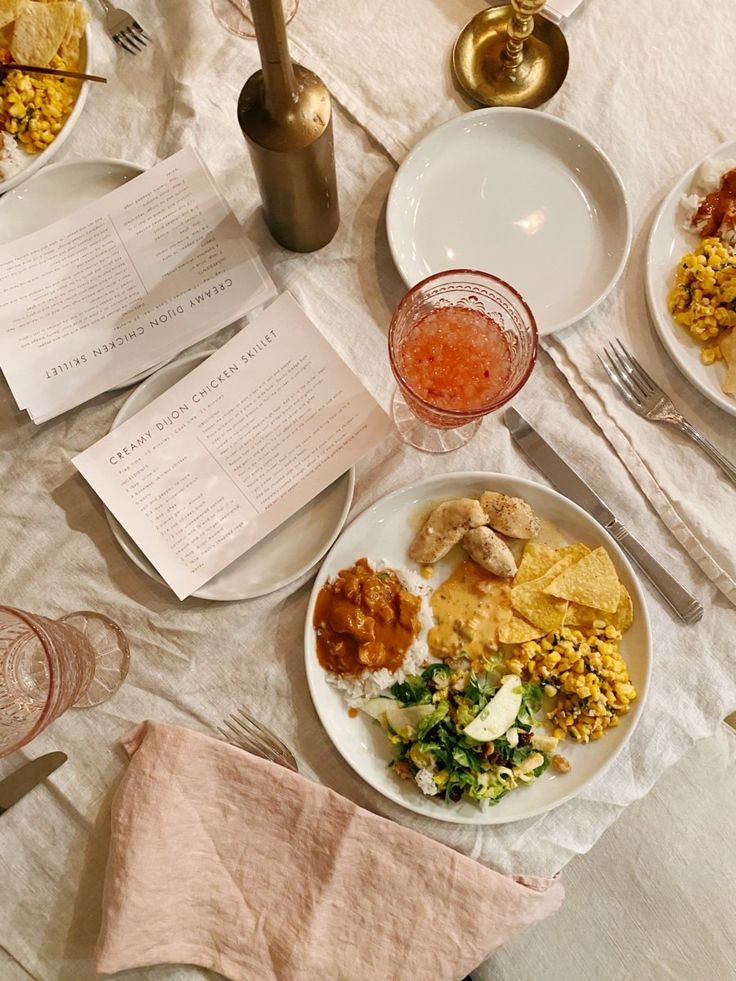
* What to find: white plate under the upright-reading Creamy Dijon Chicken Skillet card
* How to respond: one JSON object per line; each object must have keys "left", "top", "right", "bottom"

{"left": 106, "top": 351, "right": 355, "bottom": 602}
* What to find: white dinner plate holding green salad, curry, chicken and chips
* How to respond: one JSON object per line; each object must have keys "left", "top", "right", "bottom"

{"left": 304, "top": 472, "right": 651, "bottom": 824}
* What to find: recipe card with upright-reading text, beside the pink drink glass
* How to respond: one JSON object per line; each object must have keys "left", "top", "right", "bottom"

{"left": 73, "top": 293, "right": 391, "bottom": 599}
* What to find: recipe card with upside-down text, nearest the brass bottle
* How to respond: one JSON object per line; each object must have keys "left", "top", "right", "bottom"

{"left": 0, "top": 147, "right": 276, "bottom": 422}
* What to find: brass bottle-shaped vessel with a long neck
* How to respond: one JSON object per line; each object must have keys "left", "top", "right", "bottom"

{"left": 238, "top": 0, "right": 340, "bottom": 252}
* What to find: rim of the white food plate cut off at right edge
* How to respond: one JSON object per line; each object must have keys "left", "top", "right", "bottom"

{"left": 644, "top": 140, "right": 736, "bottom": 416}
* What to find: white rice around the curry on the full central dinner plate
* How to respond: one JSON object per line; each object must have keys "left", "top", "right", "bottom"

{"left": 327, "top": 558, "right": 435, "bottom": 707}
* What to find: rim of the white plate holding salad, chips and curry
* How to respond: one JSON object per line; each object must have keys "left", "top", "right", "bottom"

{"left": 304, "top": 470, "right": 653, "bottom": 827}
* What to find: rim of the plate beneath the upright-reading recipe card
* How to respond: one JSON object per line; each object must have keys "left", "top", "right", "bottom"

{"left": 103, "top": 348, "right": 355, "bottom": 603}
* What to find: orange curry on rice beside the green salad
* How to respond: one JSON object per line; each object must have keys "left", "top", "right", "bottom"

{"left": 312, "top": 559, "right": 421, "bottom": 675}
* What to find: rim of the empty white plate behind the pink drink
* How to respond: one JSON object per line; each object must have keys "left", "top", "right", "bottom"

{"left": 386, "top": 106, "right": 633, "bottom": 337}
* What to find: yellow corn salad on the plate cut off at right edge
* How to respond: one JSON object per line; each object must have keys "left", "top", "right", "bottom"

{"left": 668, "top": 238, "right": 736, "bottom": 364}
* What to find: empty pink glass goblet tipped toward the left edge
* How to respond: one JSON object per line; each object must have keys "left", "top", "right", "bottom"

{"left": 0, "top": 606, "right": 130, "bottom": 757}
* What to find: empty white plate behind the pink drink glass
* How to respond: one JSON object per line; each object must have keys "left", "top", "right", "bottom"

{"left": 386, "top": 109, "right": 631, "bottom": 335}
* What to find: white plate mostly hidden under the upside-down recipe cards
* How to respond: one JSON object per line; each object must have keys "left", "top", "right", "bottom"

{"left": 0, "top": 157, "right": 167, "bottom": 392}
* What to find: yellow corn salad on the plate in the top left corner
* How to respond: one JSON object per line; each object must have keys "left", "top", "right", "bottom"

{"left": 0, "top": 55, "right": 79, "bottom": 153}
